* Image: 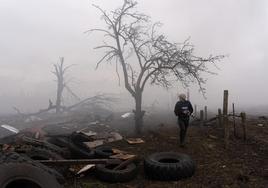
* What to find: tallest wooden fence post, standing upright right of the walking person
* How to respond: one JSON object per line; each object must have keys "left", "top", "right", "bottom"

{"left": 223, "top": 90, "right": 229, "bottom": 148}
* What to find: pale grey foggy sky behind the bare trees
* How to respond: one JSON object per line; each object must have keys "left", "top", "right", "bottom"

{"left": 0, "top": 0, "right": 268, "bottom": 113}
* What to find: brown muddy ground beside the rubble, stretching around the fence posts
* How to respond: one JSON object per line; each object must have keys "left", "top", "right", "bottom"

{"left": 58, "top": 112, "right": 268, "bottom": 188}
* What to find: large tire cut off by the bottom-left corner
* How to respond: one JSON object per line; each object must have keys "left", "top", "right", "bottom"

{"left": 0, "top": 153, "right": 61, "bottom": 188}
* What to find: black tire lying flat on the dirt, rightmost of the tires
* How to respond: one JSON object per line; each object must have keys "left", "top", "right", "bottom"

{"left": 144, "top": 152, "right": 196, "bottom": 181}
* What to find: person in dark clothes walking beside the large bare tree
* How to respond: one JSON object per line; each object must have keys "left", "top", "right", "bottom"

{"left": 174, "top": 94, "right": 193, "bottom": 147}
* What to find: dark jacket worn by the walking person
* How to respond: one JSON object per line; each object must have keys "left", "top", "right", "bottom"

{"left": 174, "top": 101, "right": 193, "bottom": 118}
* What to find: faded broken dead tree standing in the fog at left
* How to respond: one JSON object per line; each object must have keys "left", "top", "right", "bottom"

{"left": 52, "top": 57, "right": 72, "bottom": 113}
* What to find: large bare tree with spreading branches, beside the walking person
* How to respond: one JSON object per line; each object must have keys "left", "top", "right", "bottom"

{"left": 90, "top": 0, "right": 223, "bottom": 133}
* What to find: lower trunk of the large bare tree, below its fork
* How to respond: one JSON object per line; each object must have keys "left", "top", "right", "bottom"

{"left": 134, "top": 92, "right": 145, "bottom": 134}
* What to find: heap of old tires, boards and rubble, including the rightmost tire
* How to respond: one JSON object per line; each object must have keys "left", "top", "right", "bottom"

{"left": 0, "top": 122, "right": 195, "bottom": 188}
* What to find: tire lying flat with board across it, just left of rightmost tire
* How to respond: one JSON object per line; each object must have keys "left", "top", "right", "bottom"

{"left": 96, "top": 159, "right": 138, "bottom": 183}
